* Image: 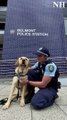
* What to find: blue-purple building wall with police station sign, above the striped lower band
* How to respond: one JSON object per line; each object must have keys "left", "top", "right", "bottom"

{"left": 0, "top": 0, "right": 67, "bottom": 59}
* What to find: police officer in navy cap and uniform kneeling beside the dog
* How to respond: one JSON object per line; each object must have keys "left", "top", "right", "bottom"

{"left": 20, "top": 47, "right": 59, "bottom": 109}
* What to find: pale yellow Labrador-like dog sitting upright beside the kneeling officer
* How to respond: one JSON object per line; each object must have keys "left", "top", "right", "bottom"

{"left": 3, "top": 56, "right": 30, "bottom": 110}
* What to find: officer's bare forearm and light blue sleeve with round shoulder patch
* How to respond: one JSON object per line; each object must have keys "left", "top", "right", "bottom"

{"left": 29, "top": 63, "right": 57, "bottom": 88}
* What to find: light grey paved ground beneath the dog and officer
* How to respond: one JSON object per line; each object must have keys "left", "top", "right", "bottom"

{"left": 0, "top": 78, "right": 67, "bottom": 120}
